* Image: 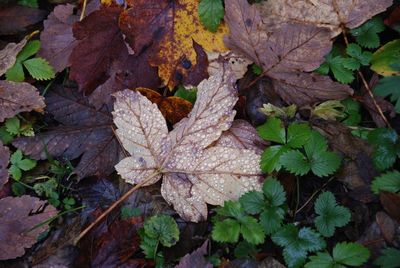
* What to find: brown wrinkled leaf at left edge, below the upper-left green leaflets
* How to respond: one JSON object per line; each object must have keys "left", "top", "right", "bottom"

{"left": 0, "top": 80, "right": 45, "bottom": 122}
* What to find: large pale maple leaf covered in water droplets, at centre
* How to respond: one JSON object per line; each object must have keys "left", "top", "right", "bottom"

{"left": 113, "top": 68, "right": 261, "bottom": 222}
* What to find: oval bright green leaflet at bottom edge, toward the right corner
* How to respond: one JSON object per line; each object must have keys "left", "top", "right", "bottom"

{"left": 332, "top": 242, "right": 370, "bottom": 266}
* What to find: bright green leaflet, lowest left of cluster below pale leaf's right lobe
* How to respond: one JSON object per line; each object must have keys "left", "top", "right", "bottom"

{"left": 211, "top": 219, "right": 240, "bottom": 243}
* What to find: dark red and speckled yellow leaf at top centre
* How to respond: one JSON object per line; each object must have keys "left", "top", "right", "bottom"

{"left": 120, "top": 0, "right": 227, "bottom": 89}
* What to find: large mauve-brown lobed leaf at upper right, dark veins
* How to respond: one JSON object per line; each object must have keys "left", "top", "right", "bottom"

{"left": 225, "top": 0, "right": 353, "bottom": 106}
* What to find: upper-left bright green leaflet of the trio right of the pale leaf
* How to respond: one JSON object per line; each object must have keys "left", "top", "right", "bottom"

{"left": 257, "top": 117, "right": 286, "bottom": 144}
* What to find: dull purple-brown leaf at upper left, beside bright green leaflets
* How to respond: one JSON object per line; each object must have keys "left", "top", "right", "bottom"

{"left": 38, "top": 4, "right": 79, "bottom": 72}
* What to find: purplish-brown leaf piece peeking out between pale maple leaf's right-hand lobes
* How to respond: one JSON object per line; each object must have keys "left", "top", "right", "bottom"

{"left": 215, "top": 119, "right": 267, "bottom": 154}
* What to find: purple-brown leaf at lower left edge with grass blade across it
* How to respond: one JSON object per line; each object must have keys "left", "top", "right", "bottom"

{"left": 0, "top": 195, "right": 57, "bottom": 260}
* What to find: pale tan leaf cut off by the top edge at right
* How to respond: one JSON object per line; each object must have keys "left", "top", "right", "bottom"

{"left": 260, "top": 0, "right": 393, "bottom": 37}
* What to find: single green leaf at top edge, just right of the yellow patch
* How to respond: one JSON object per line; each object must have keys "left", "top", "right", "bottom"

{"left": 198, "top": 0, "right": 225, "bottom": 32}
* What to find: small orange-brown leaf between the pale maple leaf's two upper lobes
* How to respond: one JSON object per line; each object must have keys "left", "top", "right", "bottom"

{"left": 135, "top": 87, "right": 193, "bottom": 125}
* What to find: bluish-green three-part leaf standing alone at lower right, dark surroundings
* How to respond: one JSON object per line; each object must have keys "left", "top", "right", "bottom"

{"left": 314, "top": 192, "right": 351, "bottom": 237}
